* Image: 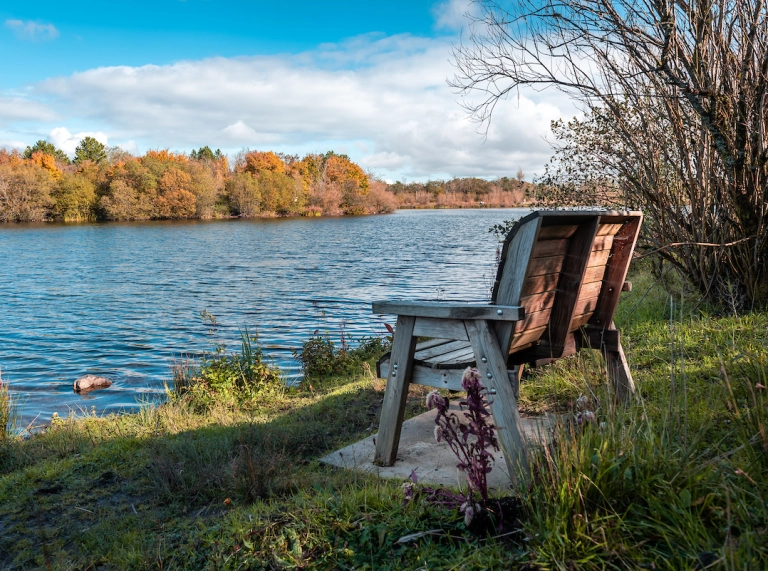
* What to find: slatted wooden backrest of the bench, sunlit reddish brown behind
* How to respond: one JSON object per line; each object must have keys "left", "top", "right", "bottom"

{"left": 492, "top": 211, "right": 642, "bottom": 358}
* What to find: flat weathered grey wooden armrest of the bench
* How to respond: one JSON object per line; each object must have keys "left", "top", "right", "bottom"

{"left": 371, "top": 300, "right": 525, "bottom": 321}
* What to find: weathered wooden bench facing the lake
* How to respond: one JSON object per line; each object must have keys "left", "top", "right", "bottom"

{"left": 373, "top": 211, "right": 642, "bottom": 474}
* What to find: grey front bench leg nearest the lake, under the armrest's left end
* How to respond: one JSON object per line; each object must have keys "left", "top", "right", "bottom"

{"left": 373, "top": 315, "right": 416, "bottom": 466}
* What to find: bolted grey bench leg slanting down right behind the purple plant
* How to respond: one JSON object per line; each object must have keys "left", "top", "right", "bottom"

{"left": 464, "top": 320, "right": 528, "bottom": 481}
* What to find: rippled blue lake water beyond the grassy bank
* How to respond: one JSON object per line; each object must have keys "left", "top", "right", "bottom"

{"left": 0, "top": 209, "right": 527, "bottom": 422}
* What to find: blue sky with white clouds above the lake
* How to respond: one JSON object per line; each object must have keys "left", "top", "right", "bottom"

{"left": 0, "top": 0, "right": 575, "bottom": 181}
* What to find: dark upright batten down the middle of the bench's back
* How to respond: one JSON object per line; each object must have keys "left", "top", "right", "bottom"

{"left": 547, "top": 216, "right": 609, "bottom": 358}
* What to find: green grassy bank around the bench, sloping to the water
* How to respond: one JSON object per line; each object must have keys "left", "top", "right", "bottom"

{"left": 0, "top": 273, "right": 768, "bottom": 569}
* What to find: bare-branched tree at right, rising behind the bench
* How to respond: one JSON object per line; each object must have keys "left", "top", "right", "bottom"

{"left": 451, "top": 0, "right": 768, "bottom": 307}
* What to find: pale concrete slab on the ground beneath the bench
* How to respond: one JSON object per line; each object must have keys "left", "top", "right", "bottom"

{"left": 320, "top": 401, "right": 555, "bottom": 489}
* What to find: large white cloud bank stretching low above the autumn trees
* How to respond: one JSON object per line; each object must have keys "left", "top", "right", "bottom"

{"left": 0, "top": 35, "right": 574, "bottom": 180}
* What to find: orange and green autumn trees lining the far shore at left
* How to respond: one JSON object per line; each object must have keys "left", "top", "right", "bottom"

{"left": 0, "top": 137, "right": 396, "bottom": 222}
